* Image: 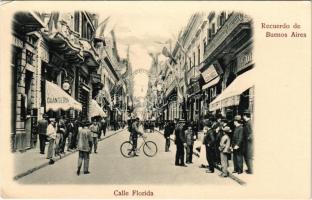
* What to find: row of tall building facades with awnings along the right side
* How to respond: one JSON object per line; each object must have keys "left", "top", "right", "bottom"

{"left": 152, "top": 11, "right": 254, "bottom": 121}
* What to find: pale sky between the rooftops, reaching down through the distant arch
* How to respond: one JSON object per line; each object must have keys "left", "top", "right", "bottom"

{"left": 98, "top": 2, "right": 198, "bottom": 96}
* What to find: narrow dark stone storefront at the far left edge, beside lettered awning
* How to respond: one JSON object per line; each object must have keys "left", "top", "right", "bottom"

{"left": 11, "top": 12, "right": 44, "bottom": 151}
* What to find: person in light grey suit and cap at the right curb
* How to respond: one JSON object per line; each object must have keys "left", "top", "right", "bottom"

{"left": 219, "top": 126, "right": 232, "bottom": 177}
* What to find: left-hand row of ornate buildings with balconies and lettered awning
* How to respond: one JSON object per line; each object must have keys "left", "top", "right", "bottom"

{"left": 11, "top": 11, "right": 132, "bottom": 151}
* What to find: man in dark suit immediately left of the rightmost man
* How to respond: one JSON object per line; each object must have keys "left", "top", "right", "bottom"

{"left": 232, "top": 115, "right": 244, "bottom": 174}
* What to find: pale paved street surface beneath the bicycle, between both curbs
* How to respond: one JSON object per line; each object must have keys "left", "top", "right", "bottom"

{"left": 19, "top": 130, "right": 238, "bottom": 186}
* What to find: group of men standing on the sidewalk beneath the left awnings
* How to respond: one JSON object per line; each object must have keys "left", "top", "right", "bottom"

{"left": 37, "top": 114, "right": 107, "bottom": 169}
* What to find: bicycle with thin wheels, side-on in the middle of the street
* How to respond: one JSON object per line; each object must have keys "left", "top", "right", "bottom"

{"left": 120, "top": 135, "right": 158, "bottom": 158}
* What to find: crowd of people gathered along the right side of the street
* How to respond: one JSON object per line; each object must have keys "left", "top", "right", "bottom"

{"left": 164, "top": 111, "right": 253, "bottom": 177}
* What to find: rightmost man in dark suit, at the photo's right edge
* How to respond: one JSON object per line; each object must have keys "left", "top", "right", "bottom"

{"left": 243, "top": 110, "right": 253, "bottom": 174}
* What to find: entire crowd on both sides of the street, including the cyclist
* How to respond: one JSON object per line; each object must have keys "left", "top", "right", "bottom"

{"left": 37, "top": 111, "right": 253, "bottom": 177}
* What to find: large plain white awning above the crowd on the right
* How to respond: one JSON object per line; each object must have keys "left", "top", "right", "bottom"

{"left": 209, "top": 70, "right": 254, "bottom": 111}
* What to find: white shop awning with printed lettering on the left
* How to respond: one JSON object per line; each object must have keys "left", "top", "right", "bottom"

{"left": 46, "top": 81, "right": 82, "bottom": 111}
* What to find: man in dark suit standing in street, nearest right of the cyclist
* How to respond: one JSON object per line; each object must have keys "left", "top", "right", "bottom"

{"left": 175, "top": 120, "right": 187, "bottom": 167}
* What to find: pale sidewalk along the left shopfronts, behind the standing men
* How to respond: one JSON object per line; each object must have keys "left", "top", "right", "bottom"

{"left": 13, "top": 129, "right": 124, "bottom": 180}
